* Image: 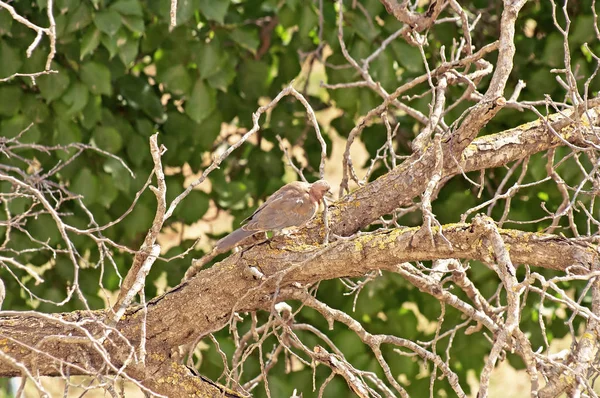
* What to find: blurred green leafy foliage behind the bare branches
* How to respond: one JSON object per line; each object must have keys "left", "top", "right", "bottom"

{"left": 0, "top": 0, "right": 600, "bottom": 397}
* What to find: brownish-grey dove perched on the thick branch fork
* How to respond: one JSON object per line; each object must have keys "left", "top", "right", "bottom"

{"left": 213, "top": 180, "right": 331, "bottom": 253}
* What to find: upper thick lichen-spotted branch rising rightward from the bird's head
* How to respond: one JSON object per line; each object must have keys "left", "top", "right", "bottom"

{"left": 314, "top": 99, "right": 600, "bottom": 242}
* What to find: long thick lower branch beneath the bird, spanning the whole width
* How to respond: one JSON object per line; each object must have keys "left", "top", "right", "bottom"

{"left": 0, "top": 224, "right": 598, "bottom": 384}
